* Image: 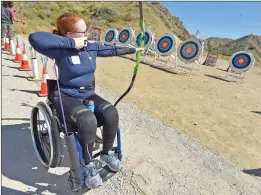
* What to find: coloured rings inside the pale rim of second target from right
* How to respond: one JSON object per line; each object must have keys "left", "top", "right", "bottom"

{"left": 180, "top": 41, "right": 199, "bottom": 60}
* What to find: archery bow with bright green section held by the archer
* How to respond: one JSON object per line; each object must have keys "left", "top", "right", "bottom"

{"left": 114, "top": 1, "right": 145, "bottom": 107}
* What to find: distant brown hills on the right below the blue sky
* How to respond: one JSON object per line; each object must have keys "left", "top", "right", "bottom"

{"left": 204, "top": 35, "right": 261, "bottom": 63}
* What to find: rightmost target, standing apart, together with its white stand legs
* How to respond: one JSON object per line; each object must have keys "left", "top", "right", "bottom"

{"left": 223, "top": 51, "right": 255, "bottom": 83}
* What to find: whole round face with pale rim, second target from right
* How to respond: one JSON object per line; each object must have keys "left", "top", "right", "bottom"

{"left": 178, "top": 38, "right": 202, "bottom": 63}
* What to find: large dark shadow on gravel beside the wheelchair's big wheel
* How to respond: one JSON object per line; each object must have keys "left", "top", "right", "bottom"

{"left": 2, "top": 122, "right": 82, "bottom": 195}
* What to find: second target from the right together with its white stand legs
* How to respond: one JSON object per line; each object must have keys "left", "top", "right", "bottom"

{"left": 174, "top": 37, "right": 203, "bottom": 76}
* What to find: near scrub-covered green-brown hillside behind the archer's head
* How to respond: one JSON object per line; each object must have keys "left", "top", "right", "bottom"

{"left": 12, "top": 2, "right": 190, "bottom": 40}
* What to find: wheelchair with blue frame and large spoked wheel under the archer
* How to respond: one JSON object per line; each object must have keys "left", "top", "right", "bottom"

{"left": 31, "top": 79, "right": 122, "bottom": 190}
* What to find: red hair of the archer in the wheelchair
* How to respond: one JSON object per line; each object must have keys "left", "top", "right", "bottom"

{"left": 53, "top": 13, "right": 82, "bottom": 36}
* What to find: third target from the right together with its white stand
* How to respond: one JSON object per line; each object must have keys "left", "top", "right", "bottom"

{"left": 152, "top": 33, "right": 177, "bottom": 68}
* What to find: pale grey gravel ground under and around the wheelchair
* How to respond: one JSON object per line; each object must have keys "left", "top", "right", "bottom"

{"left": 2, "top": 35, "right": 261, "bottom": 195}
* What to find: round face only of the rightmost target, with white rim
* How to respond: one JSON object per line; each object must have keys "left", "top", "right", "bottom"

{"left": 229, "top": 51, "right": 255, "bottom": 73}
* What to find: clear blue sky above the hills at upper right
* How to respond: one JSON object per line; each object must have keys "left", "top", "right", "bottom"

{"left": 160, "top": 2, "right": 261, "bottom": 39}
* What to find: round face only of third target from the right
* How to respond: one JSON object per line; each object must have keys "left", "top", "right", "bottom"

{"left": 155, "top": 33, "right": 177, "bottom": 56}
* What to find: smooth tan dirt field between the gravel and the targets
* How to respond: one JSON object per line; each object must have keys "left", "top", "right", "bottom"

{"left": 96, "top": 54, "right": 261, "bottom": 169}
